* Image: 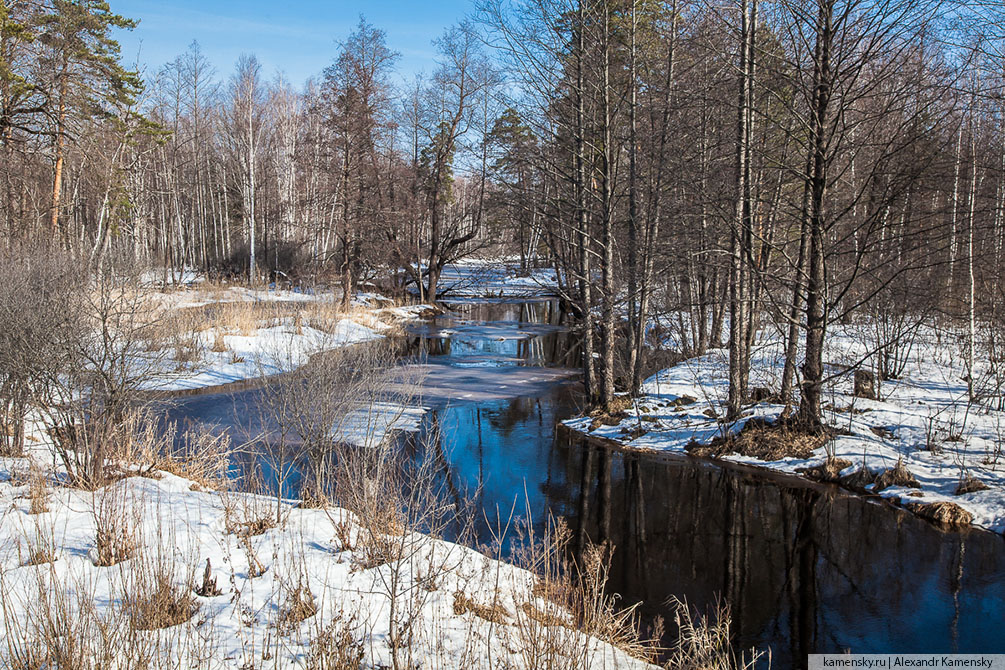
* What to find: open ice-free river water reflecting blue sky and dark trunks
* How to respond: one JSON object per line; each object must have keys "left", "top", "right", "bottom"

{"left": 160, "top": 302, "right": 1005, "bottom": 668}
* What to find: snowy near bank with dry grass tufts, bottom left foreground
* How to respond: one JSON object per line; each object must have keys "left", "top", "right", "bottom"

{"left": 0, "top": 459, "right": 650, "bottom": 669}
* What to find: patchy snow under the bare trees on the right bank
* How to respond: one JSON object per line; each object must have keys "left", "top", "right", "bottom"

{"left": 566, "top": 325, "right": 1005, "bottom": 532}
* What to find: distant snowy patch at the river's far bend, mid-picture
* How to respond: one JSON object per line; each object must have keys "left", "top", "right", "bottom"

{"left": 416, "top": 258, "right": 558, "bottom": 299}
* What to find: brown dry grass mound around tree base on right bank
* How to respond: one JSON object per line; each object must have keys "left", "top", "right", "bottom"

{"left": 687, "top": 419, "right": 830, "bottom": 461}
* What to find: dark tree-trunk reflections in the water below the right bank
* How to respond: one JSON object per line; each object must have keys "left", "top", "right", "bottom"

{"left": 565, "top": 439, "right": 1005, "bottom": 667}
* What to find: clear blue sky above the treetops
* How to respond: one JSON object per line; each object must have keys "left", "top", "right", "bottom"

{"left": 110, "top": 0, "right": 472, "bottom": 84}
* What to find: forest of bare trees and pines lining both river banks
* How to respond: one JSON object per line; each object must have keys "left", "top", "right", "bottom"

{"left": 0, "top": 0, "right": 1005, "bottom": 426}
